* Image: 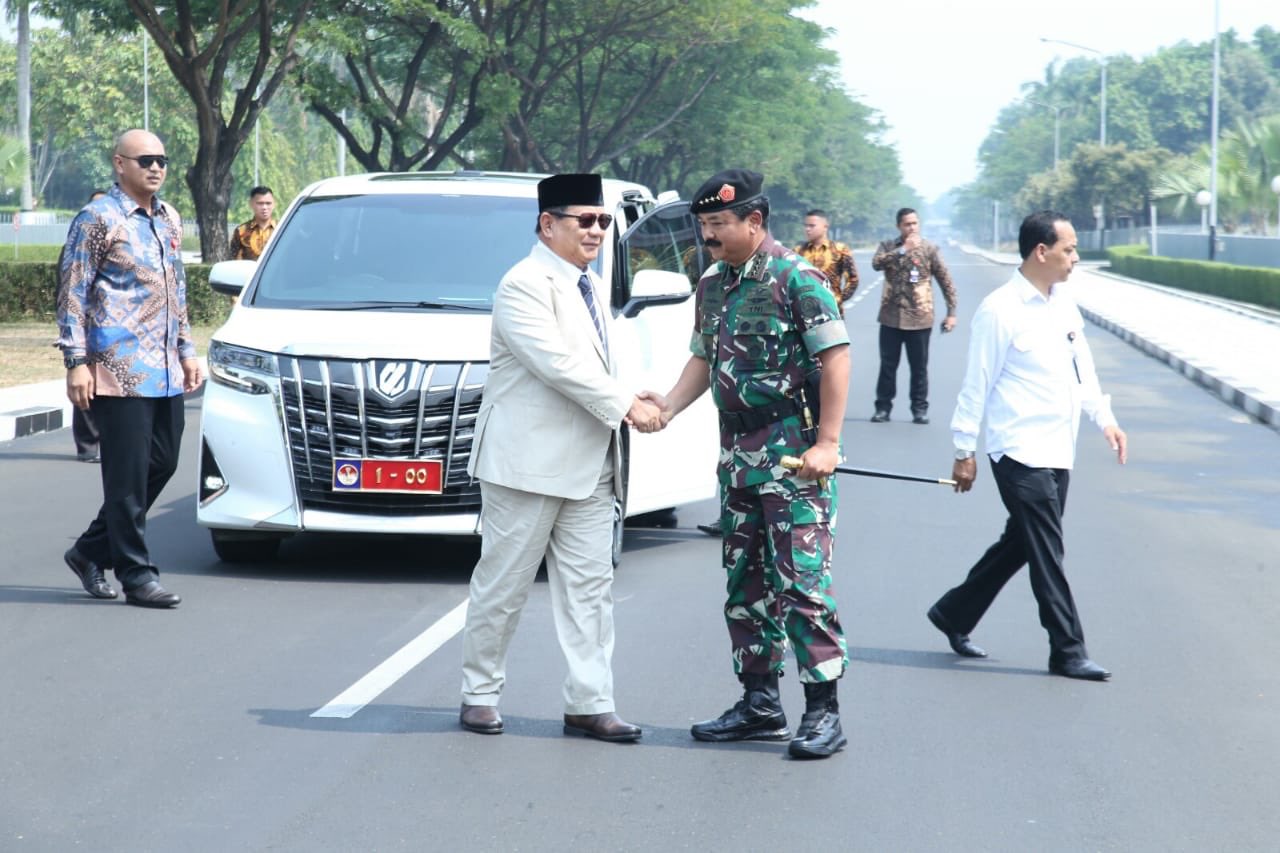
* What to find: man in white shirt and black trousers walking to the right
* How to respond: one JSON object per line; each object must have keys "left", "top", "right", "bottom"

{"left": 928, "top": 210, "right": 1128, "bottom": 681}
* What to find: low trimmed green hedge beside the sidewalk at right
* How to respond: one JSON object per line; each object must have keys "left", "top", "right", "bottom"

{"left": 1107, "top": 246, "right": 1280, "bottom": 309}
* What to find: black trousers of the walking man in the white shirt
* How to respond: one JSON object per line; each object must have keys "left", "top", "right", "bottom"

{"left": 936, "top": 456, "right": 1088, "bottom": 661}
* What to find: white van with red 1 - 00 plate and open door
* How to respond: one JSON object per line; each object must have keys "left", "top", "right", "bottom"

{"left": 196, "top": 172, "right": 718, "bottom": 562}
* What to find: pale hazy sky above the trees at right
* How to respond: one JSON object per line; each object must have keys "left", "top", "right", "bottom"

{"left": 804, "top": 0, "right": 1280, "bottom": 201}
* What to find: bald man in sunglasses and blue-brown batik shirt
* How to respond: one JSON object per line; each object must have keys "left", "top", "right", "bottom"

{"left": 58, "top": 129, "right": 204, "bottom": 607}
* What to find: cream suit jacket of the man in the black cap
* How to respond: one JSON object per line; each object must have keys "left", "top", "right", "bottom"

{"left": 467, "top": 241, "right": 635, "bottom": 501}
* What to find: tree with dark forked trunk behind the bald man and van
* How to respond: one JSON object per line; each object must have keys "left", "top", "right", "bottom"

{"left": 58, "top": 0, "right": 322, "bottom": 263}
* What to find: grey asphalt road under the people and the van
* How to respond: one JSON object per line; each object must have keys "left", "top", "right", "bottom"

{"left": 0, "top": 251, "right": 1280, "bottom": 853}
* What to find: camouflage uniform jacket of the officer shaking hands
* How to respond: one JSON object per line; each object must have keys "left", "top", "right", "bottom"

{"left": 690, "top": 237, "right": 849, "bottom": 488}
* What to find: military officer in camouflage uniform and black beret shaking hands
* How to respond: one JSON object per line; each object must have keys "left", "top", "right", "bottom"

{"left": 650, "top": 169, "right": 849, "bottom": 758}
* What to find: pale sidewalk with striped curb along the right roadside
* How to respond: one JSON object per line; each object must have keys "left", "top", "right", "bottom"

{"left": 961, "top": 246, "right": 1280, "bottom": 429}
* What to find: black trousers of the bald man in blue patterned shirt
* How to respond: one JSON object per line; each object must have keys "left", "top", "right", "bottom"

{"left": 76, "top": 396, "right": 186, "bottom": 589}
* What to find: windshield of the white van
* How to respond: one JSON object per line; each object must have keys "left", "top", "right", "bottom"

{"left": 251, "top": 195, "right": 538, "bottom": 310}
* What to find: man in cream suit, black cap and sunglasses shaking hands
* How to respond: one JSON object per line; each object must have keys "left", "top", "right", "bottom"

{"left": 460, "top": 174, "right": 660, "bottom": 742}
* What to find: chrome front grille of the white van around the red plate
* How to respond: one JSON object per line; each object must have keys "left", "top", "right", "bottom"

{"left": 279, "top": 356, "right": 489, "bottom": 516}
